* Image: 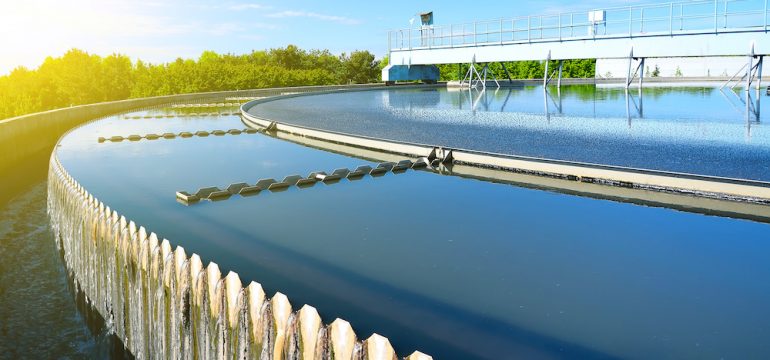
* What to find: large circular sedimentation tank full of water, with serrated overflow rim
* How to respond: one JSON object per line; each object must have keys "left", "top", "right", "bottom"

{"left": 37, "top": 83, "right": 770, "bottom": 359}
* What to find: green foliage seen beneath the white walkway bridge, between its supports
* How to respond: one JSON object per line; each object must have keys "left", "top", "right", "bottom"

{"left": 438, "top": 59, "right": 596, "bottom": 81}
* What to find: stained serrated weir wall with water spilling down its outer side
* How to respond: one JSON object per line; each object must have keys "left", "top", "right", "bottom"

{"left": 43, "top": 152, "right": 430, "bottom": 360}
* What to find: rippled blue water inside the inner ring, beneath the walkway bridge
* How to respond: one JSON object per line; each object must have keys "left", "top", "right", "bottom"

{"left": 249, "top": 85, "right": 770, "bottom": 181}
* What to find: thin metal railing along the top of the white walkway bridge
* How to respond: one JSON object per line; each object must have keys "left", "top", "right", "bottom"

{"left": 388, "top": 0, "right": 770, "bottom": 52}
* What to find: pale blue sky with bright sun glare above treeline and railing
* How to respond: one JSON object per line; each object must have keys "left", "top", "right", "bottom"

{"left": 0, "top": 0, "right": 650, "bottom": 74}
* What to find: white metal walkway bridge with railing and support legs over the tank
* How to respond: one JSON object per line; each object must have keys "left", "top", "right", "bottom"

{"left": 383, "top": 0, "right": 770, "bottom": 88}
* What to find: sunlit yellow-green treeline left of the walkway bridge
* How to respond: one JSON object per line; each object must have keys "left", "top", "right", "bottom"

{"left": 0, "top": 45, "right": 380, "bottom": 119}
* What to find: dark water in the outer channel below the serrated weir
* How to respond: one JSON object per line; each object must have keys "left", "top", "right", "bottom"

{"left": 0, "top": 173, "right": 130, "bottom": 359}
